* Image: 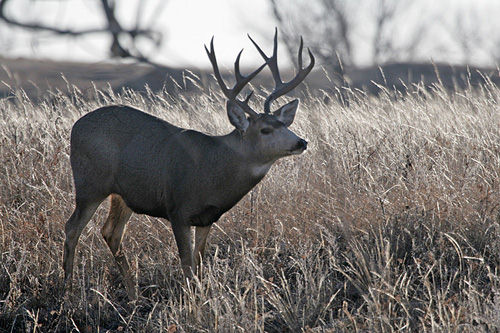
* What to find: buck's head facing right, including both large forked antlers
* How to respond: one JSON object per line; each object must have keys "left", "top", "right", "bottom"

{"left": 205, "top": 29, "right": 314, "bottom": 161}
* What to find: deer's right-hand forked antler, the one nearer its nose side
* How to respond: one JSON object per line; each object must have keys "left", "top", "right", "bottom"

{"left": 248, "top": 28, "right": 315, "bottom": 113}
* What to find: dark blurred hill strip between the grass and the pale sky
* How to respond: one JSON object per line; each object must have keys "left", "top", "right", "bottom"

{"left": 0, "top": 57, "right": 500, "bottom": 99}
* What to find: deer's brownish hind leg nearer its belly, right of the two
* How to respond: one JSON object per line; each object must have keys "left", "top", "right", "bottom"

{"left": 101, "top": 194, "right": 137, "bottom": 300}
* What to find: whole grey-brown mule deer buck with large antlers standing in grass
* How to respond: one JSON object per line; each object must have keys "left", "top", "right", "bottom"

{"left": 63, "top": 30, "right": 314, "bottom": 299}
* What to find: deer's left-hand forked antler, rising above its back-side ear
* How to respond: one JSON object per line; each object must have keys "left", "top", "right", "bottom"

{"left": 205, "top": 37, "right": 266, "bottom": 117}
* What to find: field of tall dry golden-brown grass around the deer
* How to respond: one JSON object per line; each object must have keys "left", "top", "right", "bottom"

{"left": 0, "top": 77, "right": 500, "bottom": 332}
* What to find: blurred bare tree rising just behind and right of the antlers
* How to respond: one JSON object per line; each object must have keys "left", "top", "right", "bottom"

{"left": 270, "top": 0, "right": 429, "bottom": 68}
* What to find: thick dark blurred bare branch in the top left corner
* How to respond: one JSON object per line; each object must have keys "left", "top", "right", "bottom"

{"left": 0, "top": 0, "right": 166, "bottom": 65}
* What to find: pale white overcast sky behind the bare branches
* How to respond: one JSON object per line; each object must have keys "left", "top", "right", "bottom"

{"left": 0, "top": 0, "right": 500, "bottom": 68}
